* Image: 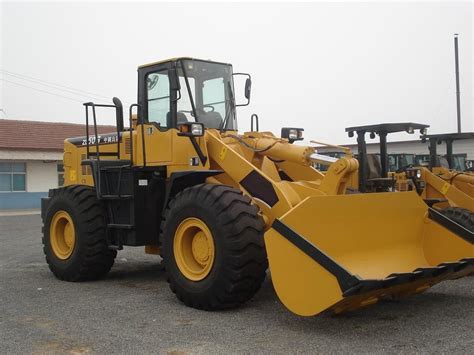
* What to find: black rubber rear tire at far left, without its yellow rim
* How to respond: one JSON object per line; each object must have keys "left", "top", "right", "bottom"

{"left": 43, "top": 185, "right": 117, "bottom": 281}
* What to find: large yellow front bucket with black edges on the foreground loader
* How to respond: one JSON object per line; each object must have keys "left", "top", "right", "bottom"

{"left": 265, "top": 192, "right": 474, "bottom": 316}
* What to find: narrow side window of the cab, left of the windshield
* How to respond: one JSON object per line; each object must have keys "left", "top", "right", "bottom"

{"left": 146, "top": 70, "right": 171, "bottom": 127}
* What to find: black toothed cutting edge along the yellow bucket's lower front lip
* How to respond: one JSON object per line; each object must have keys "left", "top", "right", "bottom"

{"left": 343, "top": 258, "right": 474, "bottom": 297}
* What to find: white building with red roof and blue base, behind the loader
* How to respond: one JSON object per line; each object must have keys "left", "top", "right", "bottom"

{"left": 0, "top": 119, "right": 116, "bottom": 210}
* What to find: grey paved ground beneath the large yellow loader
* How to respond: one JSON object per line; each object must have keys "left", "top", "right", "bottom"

{"left": 0, "top": 215, "right": 474, "bottom": 354}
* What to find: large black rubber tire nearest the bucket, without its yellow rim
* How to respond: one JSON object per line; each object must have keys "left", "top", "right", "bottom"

{"left": 162, "top": 184, "right": 268, "bottom": 311}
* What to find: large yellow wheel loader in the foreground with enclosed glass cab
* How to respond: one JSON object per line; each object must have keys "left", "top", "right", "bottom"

{"left": 42, "top": 58, "right": 474, "bottom": 316}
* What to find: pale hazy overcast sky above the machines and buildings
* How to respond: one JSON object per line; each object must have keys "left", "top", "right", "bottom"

{"left": 0, "top": 1, "right": 474, "bottom": 143}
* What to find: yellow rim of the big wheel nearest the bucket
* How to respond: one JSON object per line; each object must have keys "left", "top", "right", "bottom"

{"left": 173, "top": 217, "right": 214, "bottom": 281}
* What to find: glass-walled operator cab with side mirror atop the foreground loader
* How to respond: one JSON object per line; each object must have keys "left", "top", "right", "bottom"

{"left": 138, "top": 58, "right": 251, "bottom": 131}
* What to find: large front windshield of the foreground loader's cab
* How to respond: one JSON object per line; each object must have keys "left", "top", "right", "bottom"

{"left": 177, "top": 60, "right": 237, "bottom": 130}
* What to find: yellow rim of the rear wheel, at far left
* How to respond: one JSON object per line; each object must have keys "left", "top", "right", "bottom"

{"left": 49, "top": 211, "right": 76, "bottom": 260}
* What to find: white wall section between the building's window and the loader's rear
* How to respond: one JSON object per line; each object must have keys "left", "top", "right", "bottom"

{"left": 26, "top": 160, "right": 58, "bottom": 192}
